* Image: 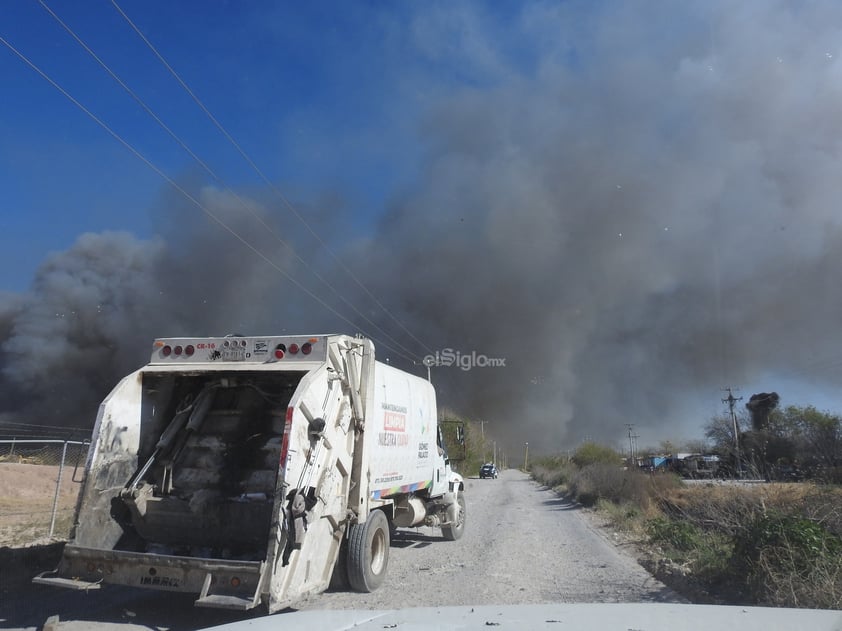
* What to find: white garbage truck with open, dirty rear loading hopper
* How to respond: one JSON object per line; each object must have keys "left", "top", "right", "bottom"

{"left": 33, "top": 335, "right": 465, "bottom": 612}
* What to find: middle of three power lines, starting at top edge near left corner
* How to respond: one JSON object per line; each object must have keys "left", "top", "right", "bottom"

{"left": 38, "top": 0, "right": 424, "bottom": 366}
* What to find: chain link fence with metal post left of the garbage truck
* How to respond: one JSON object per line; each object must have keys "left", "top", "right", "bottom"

{"left": 0, "top": 439, "right": 89, "bottom": 547}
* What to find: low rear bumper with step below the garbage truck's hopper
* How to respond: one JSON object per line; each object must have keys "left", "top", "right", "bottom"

{"left": 33, "top": 544, "right": 264, "bottom": 609}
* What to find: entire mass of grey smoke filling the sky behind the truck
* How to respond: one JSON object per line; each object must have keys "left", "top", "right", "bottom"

{"left": 0, "top": 2, "right": 842, "bottom": 451}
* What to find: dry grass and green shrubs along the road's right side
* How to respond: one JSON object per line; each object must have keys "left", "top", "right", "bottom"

{"left": 530, "top": 443, "right": 842, "bottom": 609}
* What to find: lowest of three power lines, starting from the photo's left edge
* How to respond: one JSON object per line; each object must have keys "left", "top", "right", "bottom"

{"left": 0, "top": 36, "right": 415, "bottom": 363}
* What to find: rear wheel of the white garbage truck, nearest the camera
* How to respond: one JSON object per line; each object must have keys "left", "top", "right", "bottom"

{"left": 348, "top": 510, "right": 389, "bottom": 592}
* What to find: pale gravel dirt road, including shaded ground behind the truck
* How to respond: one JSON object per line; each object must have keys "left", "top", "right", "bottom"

{"left": 0, "top": 471, "right": 681, "bottom": 631}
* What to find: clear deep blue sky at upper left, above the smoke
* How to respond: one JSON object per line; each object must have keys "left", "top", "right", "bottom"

{"left": 0, "top": 0, "right": 434, "bottom": 291}
